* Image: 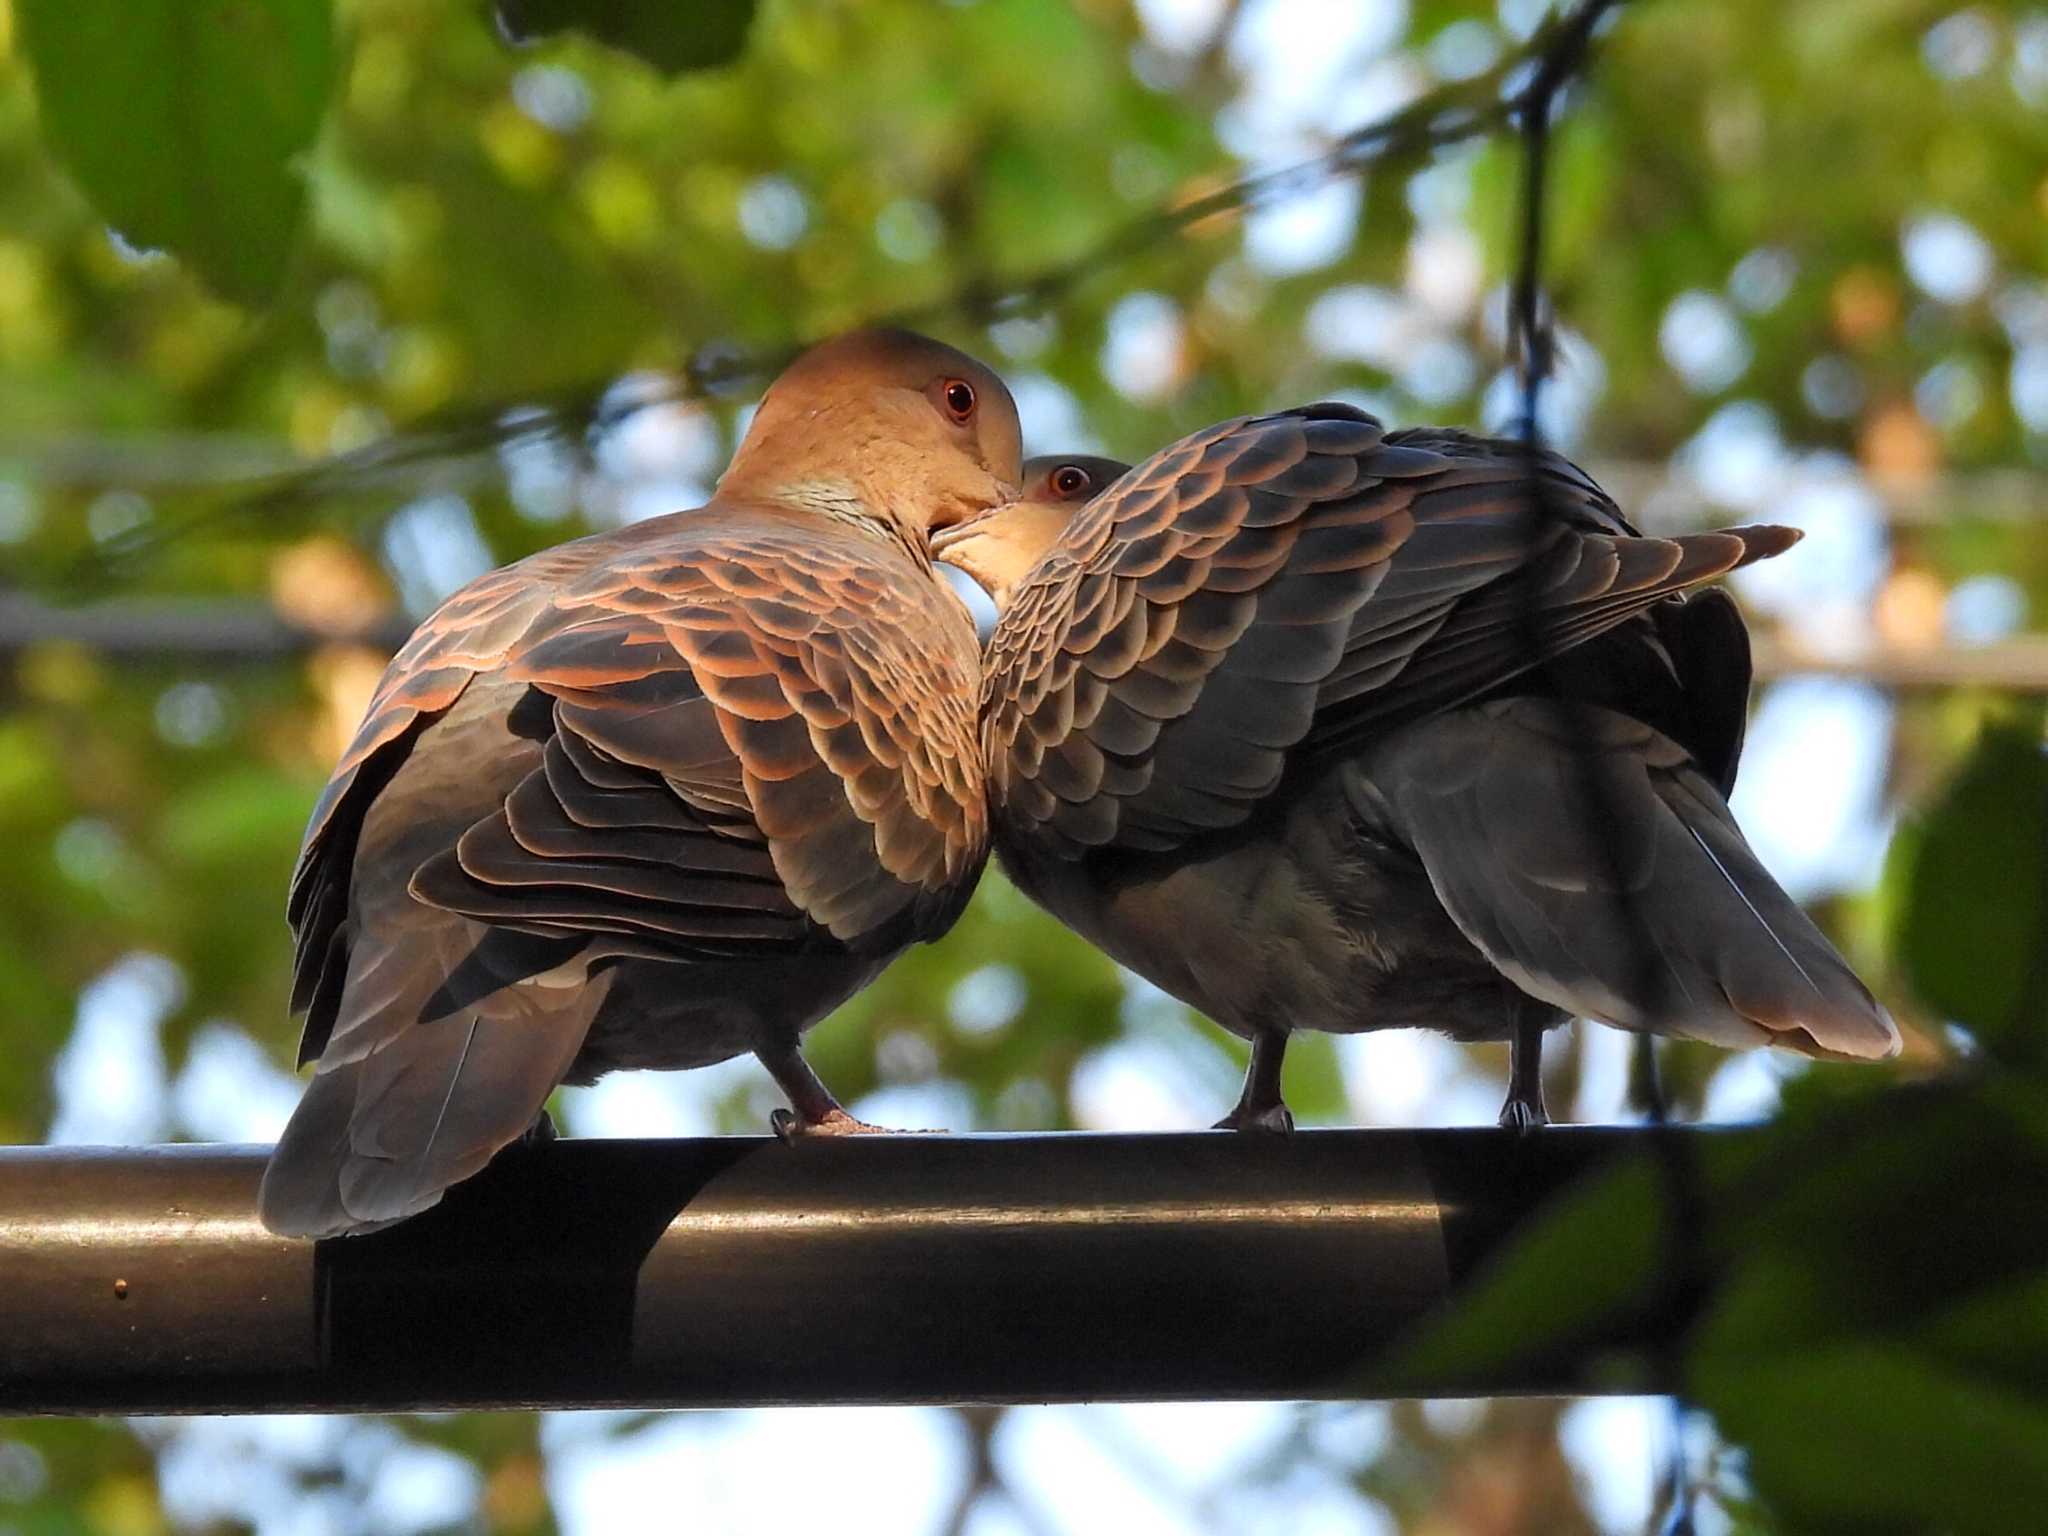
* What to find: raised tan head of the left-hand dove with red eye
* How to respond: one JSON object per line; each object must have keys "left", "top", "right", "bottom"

{"left": 719, "top": 330, "right": 1022, "bottom": 549}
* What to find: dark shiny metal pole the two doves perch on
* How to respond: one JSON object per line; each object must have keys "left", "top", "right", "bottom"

{"left": 0, "top": 1128, "right": 1739, "bottom": 1413}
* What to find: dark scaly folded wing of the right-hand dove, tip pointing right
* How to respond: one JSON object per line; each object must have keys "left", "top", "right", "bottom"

{"left": 983, "top": 403, "right": 1796, "bottom": 858}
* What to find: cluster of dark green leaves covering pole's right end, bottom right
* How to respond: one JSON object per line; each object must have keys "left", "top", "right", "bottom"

{"left": 1403, "top": 1075, "right": 2048, "bottom": 1532}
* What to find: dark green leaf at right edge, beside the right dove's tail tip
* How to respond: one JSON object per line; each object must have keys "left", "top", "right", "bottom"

{"left": 1894, "top": 725, "right": 2048, "bottom": 1053}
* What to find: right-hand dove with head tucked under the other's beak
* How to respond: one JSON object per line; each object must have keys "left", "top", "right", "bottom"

{"left": 934, "top": 415, "right": 1898, "bottom": 1128}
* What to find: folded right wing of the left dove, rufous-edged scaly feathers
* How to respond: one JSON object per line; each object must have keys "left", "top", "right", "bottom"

{"left": 414, "top": 532, "right": 985, "bottom": 952}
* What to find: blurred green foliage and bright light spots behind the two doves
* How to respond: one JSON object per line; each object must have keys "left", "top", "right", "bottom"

{"left": 0, "top": 0, "right": 2048, "bottom": 1536}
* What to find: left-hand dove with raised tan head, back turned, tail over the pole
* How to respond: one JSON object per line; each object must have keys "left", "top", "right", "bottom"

{"left": 260, "top": 332, "right": 1018, "bottom": 1237}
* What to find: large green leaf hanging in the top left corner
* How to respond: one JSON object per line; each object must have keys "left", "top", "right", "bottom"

{"left": 20, "top": 0, "right": 334, "bottom": 303}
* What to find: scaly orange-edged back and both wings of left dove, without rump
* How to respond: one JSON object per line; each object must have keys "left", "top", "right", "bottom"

{"left": 289, "top": 508, "right": 987, "bottom": 1059}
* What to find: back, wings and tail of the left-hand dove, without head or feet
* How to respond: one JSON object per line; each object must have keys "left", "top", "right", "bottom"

{"left": 262, "top": 514, "right": 985, "bottom": 1235}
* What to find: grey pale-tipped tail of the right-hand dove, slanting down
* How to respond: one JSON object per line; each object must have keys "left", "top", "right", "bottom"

{"left": 1352, "top": 698, "right": 1898, "bottom": 1059}
